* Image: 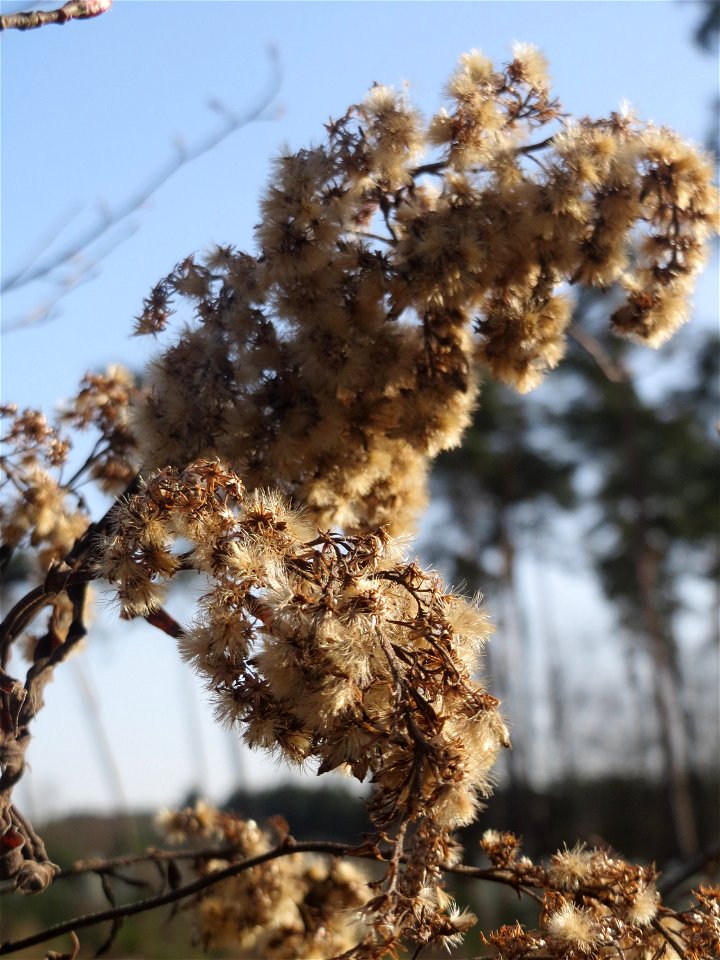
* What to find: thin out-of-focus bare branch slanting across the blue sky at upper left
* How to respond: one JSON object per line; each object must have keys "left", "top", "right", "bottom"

{"left": 0, "top": 48, "right": 282, "bottom": 332}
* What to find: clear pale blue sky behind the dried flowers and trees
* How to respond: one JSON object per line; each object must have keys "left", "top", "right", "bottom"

{"left": 1, "top": 0, "right": 718, "bottom": 815}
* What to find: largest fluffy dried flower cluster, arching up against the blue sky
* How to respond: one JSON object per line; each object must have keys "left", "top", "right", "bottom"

{"left": 136, "top": 46, "right": 717, "bottom": 533}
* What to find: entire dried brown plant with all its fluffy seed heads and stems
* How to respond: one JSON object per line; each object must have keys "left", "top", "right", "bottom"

{"left": 0, "top": 47, "right": 720, "bottom": 960}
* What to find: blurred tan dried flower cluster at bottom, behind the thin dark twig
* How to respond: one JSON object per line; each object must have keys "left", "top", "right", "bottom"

{"left": 158, "top": 802, "right": 370, "bottom": 960}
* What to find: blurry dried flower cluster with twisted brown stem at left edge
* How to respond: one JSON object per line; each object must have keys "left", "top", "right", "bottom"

{"left": 0, "top": 367, "right": 137, "bottom": 893}
